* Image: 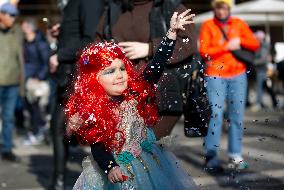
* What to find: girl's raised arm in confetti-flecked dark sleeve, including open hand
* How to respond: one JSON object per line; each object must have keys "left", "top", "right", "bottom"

{"left": 143, "top": 9, "right": 194, "bottom": 83}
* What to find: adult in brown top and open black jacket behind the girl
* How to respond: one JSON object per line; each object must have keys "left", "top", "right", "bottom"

{"left": 94, "top": 0, "right": 197, "bottom": 139}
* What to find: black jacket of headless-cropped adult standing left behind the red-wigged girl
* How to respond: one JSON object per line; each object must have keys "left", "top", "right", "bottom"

{"left": 54, "top": 0, "right": 104, "bottom": 101}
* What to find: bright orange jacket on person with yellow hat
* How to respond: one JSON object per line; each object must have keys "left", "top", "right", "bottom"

{"left": 199, "top": 17, "right": 259, "bottom": 78}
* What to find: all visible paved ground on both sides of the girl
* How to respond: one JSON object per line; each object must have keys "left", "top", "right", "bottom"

{"left": 0, "top": 107, "right": 284, "bottom": 190}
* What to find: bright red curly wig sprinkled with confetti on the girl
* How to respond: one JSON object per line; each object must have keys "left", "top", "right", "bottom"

{"left": 65, "top": 42, "right": 158, "bottom": 150}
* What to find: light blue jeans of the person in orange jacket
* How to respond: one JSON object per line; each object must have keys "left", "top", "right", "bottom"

{"left": 205, "top": 73, "right": 247, "bottom": 157}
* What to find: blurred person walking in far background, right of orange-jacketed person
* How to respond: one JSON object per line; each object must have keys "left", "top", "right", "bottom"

{"left": 250, "top": 30, "right": 277, "bottom": 112}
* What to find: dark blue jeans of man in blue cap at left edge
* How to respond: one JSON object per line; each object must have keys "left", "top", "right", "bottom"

{"left": 0, "top": 86, "right": 19, "bottom": 152}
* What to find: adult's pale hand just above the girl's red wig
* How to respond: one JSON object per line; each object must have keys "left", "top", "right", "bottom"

{"left": 118, "top": 42, "right": 149, "bottom": 60}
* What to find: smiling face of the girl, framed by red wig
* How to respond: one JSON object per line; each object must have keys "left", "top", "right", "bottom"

{"left": 97, "top": 59, "right": 128, "bottom": 96}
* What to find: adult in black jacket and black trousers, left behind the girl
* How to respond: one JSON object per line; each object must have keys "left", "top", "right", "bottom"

{"left": 49, "top": 0, "right": 104, "bottom": 190}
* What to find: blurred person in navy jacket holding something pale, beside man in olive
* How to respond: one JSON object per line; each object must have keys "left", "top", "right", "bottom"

{"left": 21, "top": 18, "right": 49, "bottom": 145}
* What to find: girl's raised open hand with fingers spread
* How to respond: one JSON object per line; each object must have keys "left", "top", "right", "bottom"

{"left": 167, "top": 9, "right": 195, "bottom": 40}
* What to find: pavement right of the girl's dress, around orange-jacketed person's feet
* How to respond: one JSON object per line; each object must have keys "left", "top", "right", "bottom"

{"left": 173, "top": 112, "right": 284, "bottom": 190}
